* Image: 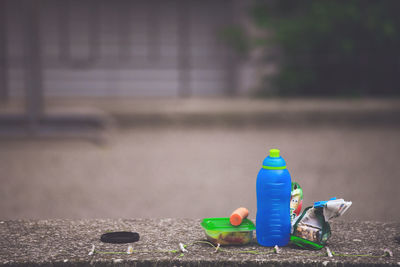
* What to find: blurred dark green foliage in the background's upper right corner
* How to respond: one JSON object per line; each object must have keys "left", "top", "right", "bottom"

{"left": 242, "top": 0, "right": 400, "bottom": 96}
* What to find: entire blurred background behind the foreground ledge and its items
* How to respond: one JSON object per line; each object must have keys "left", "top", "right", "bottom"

{"left": 0, "top": 0, "right": 400, "bottom": 221}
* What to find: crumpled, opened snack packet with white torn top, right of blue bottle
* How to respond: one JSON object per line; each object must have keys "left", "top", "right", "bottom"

{"left": 290, "top": 198, "right": 352, "bottom": 249}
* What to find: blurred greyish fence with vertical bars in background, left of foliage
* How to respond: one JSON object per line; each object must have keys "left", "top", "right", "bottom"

{"left": 0, "top": 0, "right": 236, "bottom": 99}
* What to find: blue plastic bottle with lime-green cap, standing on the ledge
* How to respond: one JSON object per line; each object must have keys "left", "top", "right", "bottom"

{"left": 256, "top": 149, "right": 292, "bottom": 247}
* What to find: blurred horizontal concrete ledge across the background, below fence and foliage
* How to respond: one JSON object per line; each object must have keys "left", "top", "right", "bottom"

{"left": 0, "top": 97, "right": 400, "bottom": 127}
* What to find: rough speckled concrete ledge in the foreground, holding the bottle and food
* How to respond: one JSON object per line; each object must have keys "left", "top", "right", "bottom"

{"left": 0, "top": 219, "right": 400, "bottom": 266}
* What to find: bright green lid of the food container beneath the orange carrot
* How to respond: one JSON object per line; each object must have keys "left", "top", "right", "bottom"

{"left": 201, "top": 217, "right": 256, "bottom": 232}
